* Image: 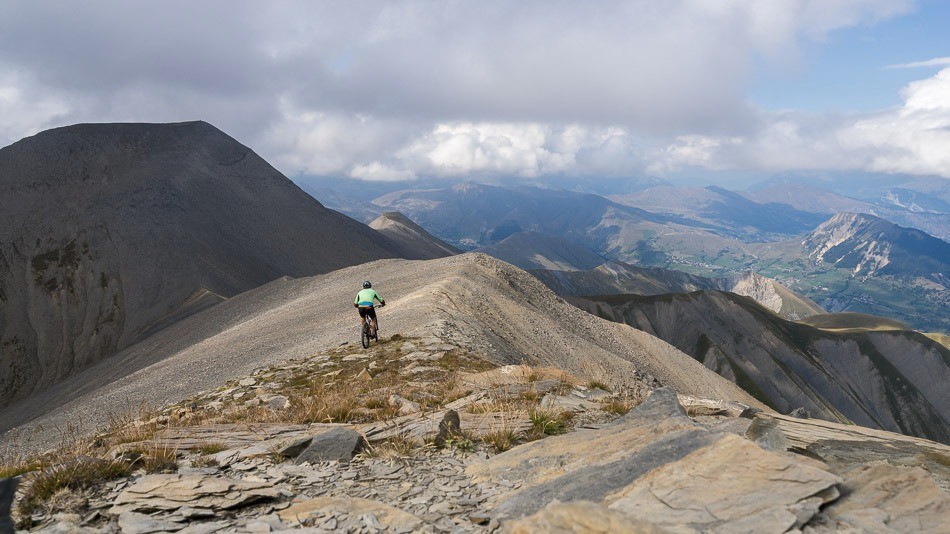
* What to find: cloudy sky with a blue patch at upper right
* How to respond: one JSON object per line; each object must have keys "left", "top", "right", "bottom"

{"left": 0, "top": 0, "right": 950, "bottom": 181}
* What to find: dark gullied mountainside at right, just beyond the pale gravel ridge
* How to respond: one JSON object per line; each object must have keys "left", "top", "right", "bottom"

{"left": 571, "top": 291, "right": 950, "bottom": 443}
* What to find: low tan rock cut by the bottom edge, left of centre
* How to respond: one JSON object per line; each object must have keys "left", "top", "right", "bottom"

{"left": 277, "top": 497, "right": 425, "bottom": 532}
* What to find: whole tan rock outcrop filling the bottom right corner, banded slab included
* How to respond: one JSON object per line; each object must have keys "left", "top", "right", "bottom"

{"left": 467, "top": 389, "right": 950, "bottom": 532}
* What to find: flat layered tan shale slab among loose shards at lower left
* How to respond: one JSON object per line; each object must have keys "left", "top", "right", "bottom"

{"left": 111, "top": 475, "right": 280, "bottom": 514}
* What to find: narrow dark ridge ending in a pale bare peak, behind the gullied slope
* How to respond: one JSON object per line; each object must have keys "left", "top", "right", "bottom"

{"left": 529, "top": 262, "right": 825, "bottom": 320}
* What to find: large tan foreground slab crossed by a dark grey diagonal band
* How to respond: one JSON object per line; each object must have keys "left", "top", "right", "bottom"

{"left": 467, "top": 388, "right": 841, "bottom": 532}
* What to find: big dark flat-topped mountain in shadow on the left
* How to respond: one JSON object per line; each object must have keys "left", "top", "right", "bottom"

{"left": 0, "top": 122, "right": 406, "bottom": 405}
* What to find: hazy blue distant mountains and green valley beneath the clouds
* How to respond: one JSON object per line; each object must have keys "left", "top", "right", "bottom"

{"left": 326, "top": 183, "right": 950, "bottom": 332}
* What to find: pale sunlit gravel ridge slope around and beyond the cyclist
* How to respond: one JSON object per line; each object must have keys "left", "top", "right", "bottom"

{"left": 0, "top": 254, "right": 762, "bottom": 452}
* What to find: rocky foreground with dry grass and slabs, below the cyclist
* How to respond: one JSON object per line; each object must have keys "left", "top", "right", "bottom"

{"left": 3, "top": 337, "right": 950, "bottom": 534}
